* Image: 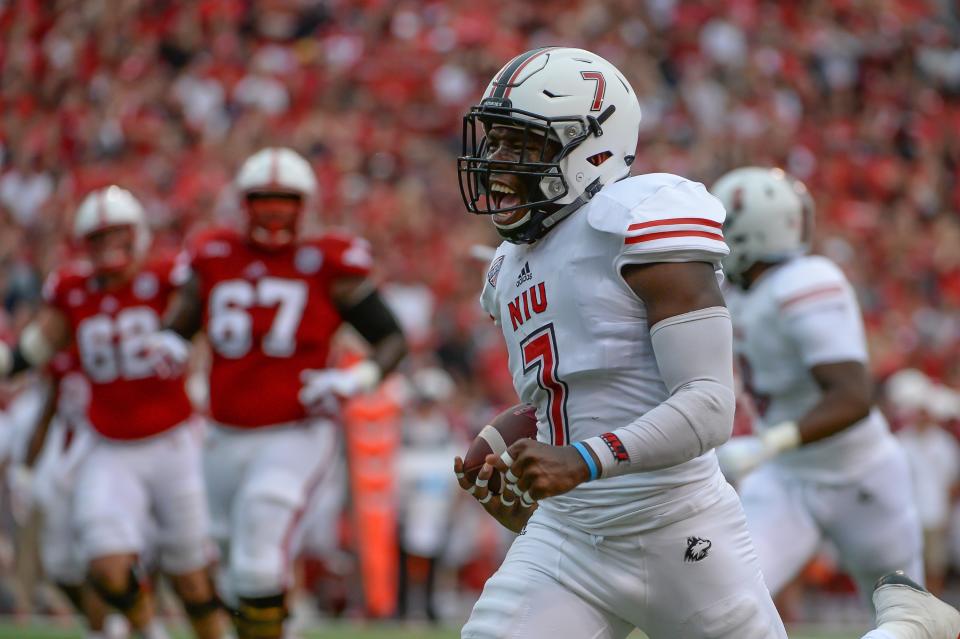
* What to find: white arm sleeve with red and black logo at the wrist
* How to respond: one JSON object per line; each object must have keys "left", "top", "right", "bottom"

{"left": 584, "top": 307, "right": 736, "bottom": 477}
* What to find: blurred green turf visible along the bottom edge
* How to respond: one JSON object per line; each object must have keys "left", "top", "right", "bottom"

{"left": 0, "top": 623, "right": 860, "bottom": 639}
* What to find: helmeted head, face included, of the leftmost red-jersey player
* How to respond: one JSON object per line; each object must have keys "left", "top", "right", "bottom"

{"left": 73, "top": 186, "right": 150, "bottom": 274}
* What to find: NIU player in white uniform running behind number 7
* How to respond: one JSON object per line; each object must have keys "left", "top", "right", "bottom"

{"left": 712, "top": 167, "right": 923, "bottom": 608}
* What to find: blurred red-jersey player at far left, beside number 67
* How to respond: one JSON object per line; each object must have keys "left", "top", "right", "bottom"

{"left": 0, "top": 186, "right": 223, "bottom": 639}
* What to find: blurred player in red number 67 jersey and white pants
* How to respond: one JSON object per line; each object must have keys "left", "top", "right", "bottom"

{"left": 151, "top": 148, "right": 406, "bottom": 639}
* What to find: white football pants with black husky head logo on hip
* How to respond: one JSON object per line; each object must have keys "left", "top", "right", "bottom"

{"left": 461, "top": 484, "right": 787, "bottom": 639}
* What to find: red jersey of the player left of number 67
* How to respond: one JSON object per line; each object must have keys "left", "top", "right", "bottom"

{"left": 44, "top": 259, "right": 193, "bottom": 440}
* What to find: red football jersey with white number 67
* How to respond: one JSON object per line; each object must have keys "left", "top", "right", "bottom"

{"left": 177, "top": 229, "right": 371, "bottom": 428}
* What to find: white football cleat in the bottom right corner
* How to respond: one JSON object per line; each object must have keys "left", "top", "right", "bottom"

{"left": 873, "top": 570, "right": 960, "bottom": 639}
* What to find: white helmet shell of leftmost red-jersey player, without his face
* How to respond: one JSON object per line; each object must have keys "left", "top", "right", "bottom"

{"left": 73, "top": 185, "right": 150, "bottom": 271}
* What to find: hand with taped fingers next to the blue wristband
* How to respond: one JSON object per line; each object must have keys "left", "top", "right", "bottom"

{"left": 486, "top": 439, "right": 590, "bottom": 503}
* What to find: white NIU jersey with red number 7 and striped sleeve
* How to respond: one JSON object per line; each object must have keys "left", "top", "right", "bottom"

{"left": 481, "top": 173, "right": 727, "bottom": 535}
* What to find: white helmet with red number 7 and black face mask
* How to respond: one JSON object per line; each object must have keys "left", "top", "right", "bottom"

{"left": 458, "top": 47, "right": 640, "bottom": 243}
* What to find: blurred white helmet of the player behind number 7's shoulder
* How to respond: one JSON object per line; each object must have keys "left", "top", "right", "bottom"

{"left": 710, "top": 166, "right": 813, "bottom": 280}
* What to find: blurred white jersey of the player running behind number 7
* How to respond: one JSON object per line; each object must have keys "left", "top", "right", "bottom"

{"left": 724, "top": 255, "right": 897, "bottom": 482}
